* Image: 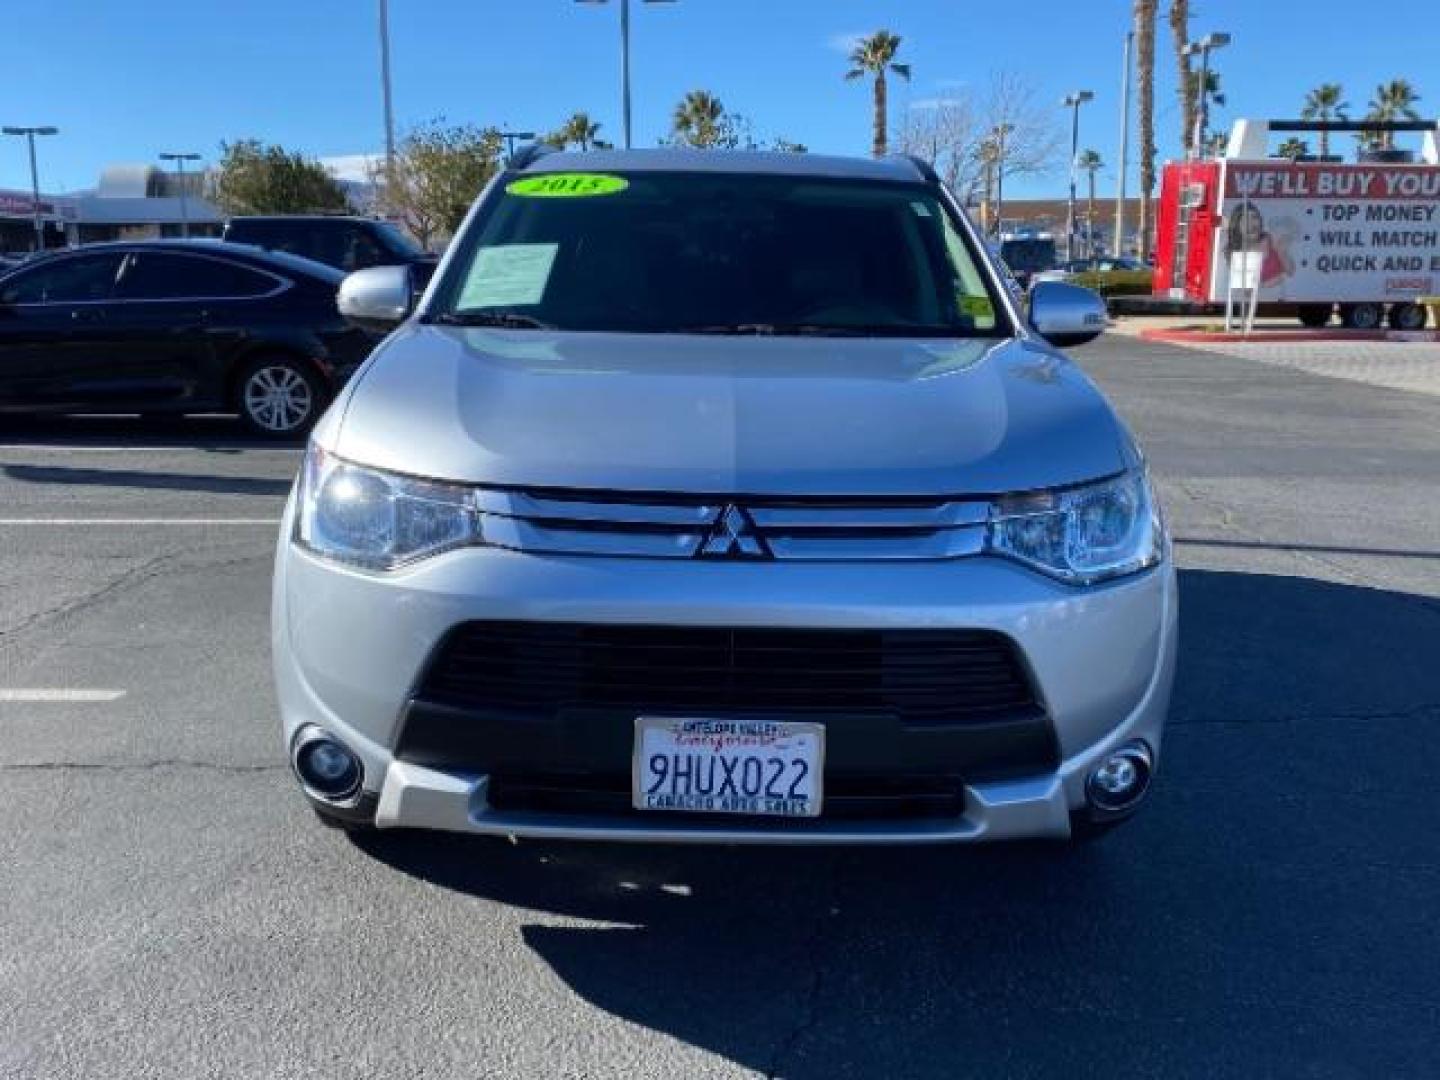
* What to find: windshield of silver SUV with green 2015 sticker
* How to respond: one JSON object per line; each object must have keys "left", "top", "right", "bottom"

{"left": 428, "top": 173, "right": 1001, "bottom": 337}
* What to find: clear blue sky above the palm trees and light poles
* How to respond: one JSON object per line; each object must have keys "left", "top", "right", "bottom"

{"left": 0, "top": 0, "right": 1440, "bottom": 196}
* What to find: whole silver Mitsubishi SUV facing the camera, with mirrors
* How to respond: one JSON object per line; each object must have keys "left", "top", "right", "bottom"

{"left": 274, "top": 151, "right": 1175, "bottom": 842}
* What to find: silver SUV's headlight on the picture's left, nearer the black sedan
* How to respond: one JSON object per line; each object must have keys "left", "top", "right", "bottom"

{"left": 295, "top": 445, "right": 481, "bottom": 570}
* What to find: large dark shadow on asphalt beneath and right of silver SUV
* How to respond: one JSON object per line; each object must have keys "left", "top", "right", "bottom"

{"left": 361, "top": 570, "right": 1440, "bottom": 1079}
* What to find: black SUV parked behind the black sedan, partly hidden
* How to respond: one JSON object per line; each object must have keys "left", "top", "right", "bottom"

{"left": 223, "top": 215, "right": 438, "bottom": 289}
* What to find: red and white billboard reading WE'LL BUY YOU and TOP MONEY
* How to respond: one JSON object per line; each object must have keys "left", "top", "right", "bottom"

{"left": 1212, "top": 161, "right": 1440, "bottom": 302}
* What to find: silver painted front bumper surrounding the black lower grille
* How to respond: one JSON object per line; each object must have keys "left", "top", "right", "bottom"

{"left": 274, "top": 498, "right": 1176, "bottom": 844}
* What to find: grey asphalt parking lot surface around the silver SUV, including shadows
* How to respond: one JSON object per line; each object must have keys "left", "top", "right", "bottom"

{"left": 0, "top": 336, "right": 1440, "bottom": 1080}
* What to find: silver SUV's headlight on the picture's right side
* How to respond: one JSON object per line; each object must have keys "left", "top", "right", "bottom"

{"left": 986, "top": 471, "right": 1165, "bottom": 585}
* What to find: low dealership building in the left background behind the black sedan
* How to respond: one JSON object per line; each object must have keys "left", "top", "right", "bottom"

{"left": 0, "top": 166, "right": 225, "bottom": 251}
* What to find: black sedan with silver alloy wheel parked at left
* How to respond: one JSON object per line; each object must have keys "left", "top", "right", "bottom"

{"left": 0, "top": 240, "right": 377, "bottom": 436}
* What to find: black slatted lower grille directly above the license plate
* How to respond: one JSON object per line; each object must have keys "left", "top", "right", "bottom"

{"left": 418, "top": 622, "right": 1037, "bottom": 726}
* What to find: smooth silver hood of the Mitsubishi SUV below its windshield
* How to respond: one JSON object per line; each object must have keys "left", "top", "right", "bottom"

{"left": 326, "top": 323, "right": 1125, "bottom": 495}
